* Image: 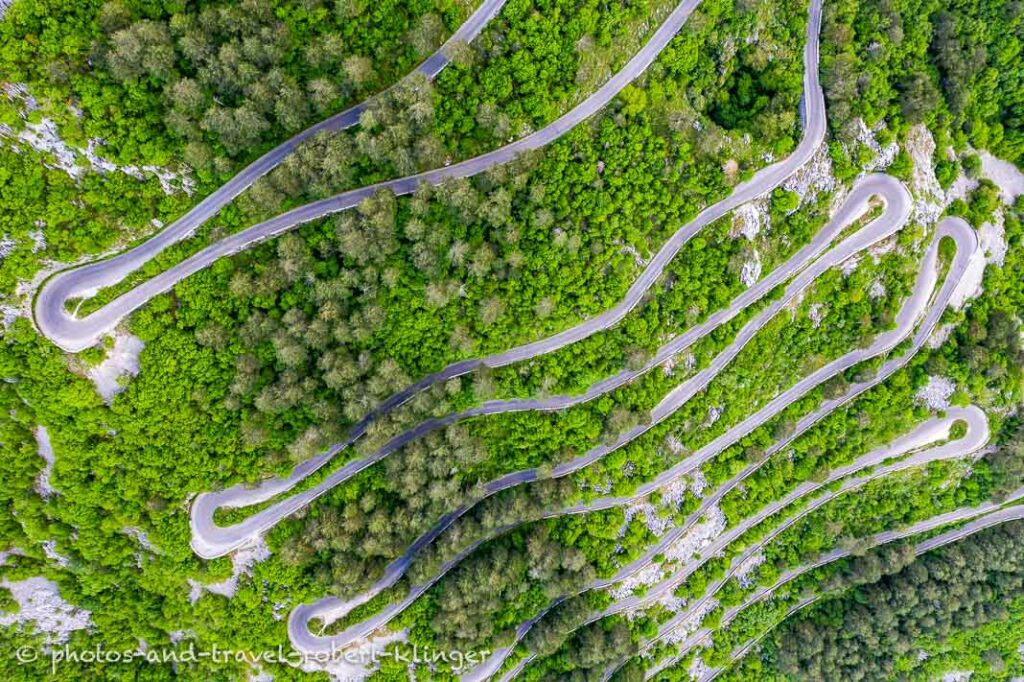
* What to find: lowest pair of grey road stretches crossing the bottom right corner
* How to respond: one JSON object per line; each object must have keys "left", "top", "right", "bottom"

{"left": 667, "top": 488, "right": 1024, "bottom": 682}
